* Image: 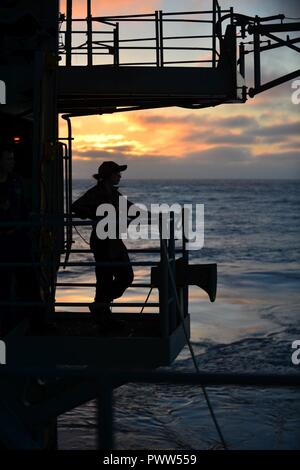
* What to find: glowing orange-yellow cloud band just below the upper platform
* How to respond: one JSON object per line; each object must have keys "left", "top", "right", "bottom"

{"left": 61, "top": 100, "right": 300, "bottom": 170}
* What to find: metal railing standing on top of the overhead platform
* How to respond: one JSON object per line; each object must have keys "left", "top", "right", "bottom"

{"left": 59, "top": 0, "right": 232, "bottom": 68}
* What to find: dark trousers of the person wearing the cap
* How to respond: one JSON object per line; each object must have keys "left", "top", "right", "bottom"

{"left": 91, "top": 233, "right": 134, "bottom": 302}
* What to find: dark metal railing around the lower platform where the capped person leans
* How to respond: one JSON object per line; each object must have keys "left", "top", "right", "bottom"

{"left": 0, "top": 211, "right": 188, "bottom": 337}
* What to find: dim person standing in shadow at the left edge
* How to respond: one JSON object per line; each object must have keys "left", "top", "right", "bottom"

{"left": 0, "top": 146, "right": 42, "bottom": 336}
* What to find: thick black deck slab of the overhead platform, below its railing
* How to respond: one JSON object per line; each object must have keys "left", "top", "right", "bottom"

{"left": 58, "top": 65, "right": 243, "bottom": 113}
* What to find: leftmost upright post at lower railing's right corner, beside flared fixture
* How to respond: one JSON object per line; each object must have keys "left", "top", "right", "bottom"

{"left": 159, "top": 213, "right": 169, "bottom": 337}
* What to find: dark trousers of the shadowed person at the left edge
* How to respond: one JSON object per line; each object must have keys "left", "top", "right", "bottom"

{"left": 0, "top": 233, "right": 44, "bottom": 336}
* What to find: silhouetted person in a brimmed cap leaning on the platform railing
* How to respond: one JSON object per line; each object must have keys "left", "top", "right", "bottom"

{"left": 72, "top": 161, "right": 134, "bottom": 326}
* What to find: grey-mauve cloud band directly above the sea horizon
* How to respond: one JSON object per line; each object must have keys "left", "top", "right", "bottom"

{"left": 73, "top": 146, "right": 300, "bottom": 179}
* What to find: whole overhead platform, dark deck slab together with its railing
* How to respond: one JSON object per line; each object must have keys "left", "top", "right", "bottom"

{"left": 57, "top": 7, "right": 246, "bottom": 115}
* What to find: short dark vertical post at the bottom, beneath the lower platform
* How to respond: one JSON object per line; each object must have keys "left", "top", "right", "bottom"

{"left": 97, "top": 382, "right": 114, "bottom": 450}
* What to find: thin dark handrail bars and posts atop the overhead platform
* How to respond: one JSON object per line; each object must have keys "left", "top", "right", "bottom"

{"left": 60, "top": 0, "right": 231, "bottom": 67}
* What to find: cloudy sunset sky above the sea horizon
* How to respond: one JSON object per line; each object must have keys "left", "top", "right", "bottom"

{"left": 61, "top": 0, "right": 300, "bottom": 179}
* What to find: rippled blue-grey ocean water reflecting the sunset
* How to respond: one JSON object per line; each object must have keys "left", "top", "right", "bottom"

{"left": 57, "top": 179, "right": 300, "bottom": 450}
